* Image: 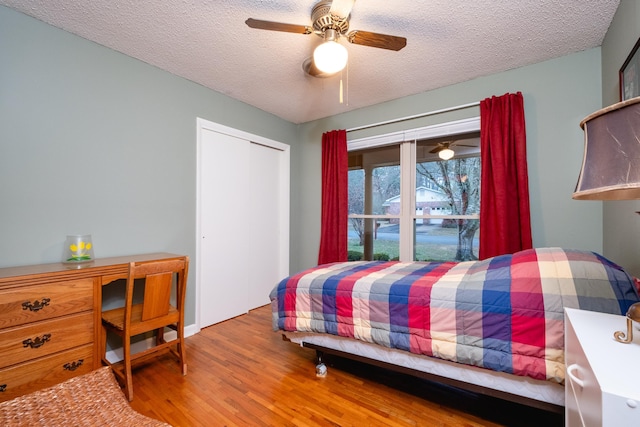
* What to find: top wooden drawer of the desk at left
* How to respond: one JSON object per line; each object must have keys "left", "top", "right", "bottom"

{"left": 0, "top": 278, "right": 93, "bottom": 329}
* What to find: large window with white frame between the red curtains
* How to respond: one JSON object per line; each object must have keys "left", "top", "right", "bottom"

{"left": 348, "top": 118, "right": 480, "bottom": 261}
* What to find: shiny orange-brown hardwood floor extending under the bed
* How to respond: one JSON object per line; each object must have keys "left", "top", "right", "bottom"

{"left": 132, "top": 306, "right": 563, "bottom": 427}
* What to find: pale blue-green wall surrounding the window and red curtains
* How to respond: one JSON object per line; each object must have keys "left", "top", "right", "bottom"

{"left": 292, "top": 48, "right": 602, "bottom": 269}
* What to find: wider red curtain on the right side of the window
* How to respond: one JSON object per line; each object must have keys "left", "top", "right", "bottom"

{"left": 479, "top": 92, "right": 532, "bottom": 259}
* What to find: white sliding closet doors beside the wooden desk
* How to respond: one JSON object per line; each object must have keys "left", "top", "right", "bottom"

{"left": 196, "top": 121, "right": 289, "bottom": 328}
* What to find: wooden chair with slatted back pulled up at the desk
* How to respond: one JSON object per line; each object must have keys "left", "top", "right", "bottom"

{"left": 102, "top": 257, "right": 189, "bottom": 401}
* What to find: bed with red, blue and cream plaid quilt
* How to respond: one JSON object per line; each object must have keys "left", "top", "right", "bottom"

{"left": 270, "top": 248, "right": 640, "bottom": 411}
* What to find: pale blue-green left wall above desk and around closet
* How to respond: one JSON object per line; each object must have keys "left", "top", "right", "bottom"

{"left": 0, "top": 6, "right": 296, "bottom": 324}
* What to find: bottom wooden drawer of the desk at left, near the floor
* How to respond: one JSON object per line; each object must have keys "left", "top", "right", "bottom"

{"left": 0, "top": 344, "right": 93, "bottom": 401}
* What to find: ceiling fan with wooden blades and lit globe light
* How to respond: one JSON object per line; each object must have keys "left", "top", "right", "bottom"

{"left": 245, "top": 0, "right": 407, "bottom": 77}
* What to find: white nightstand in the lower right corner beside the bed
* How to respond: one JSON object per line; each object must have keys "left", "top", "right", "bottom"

{"left": 565, "top": 308, "right": 640, "bottom": 427}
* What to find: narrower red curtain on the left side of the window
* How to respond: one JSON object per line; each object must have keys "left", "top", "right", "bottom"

{"left": 318, "top": 130, "right": 349, "bottom": 264}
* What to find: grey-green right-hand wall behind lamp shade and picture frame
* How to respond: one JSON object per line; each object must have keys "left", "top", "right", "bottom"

{"left": 594, "top": 0, "right": 640, "bottom": 277}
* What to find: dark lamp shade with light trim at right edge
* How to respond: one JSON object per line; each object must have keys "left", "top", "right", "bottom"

{"left": 573, "top": 97, "right": 640, "bottom": 200}
